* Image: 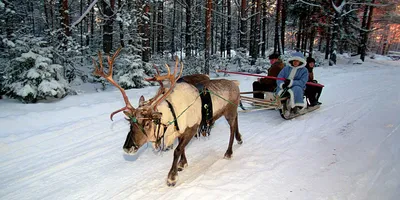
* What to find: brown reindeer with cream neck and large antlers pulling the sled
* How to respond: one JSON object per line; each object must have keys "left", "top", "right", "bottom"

{"left": 93, "top": 49, "right": 242, "bottom": 186}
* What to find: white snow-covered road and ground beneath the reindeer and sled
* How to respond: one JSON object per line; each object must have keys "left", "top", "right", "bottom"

{"left": 0, "top": 59, "right": 400, "bottom": 200}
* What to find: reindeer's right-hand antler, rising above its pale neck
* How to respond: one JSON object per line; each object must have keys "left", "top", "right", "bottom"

{"left": 146, "top": 56, "right": 183, "bottom": 109}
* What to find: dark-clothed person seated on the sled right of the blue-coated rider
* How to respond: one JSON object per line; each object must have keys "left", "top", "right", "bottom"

{"left": 304, "top": 57, "right": 322, "bottom": 106}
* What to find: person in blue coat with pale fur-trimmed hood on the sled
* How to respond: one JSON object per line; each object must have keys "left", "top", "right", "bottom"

{"left": 276, "top": 52, "right": 308, "bottom": 113}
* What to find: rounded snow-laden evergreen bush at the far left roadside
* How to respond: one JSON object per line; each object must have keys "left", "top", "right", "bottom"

{"left": 4, "top": 51, "right": 68, "bottom": 103}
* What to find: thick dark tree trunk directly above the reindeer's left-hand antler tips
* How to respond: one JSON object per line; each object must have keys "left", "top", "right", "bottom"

{"left": 102, "top": 0, "right": 115, "bottom": 54}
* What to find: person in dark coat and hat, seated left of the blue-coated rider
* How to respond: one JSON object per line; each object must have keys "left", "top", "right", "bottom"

{"left": 253, "top": 53, "right": 284, "bottom": 99}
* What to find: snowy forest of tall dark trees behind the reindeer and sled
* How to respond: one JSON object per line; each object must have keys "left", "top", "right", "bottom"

{"left": 0, "top": 0, "right": 400, "bottom": 103}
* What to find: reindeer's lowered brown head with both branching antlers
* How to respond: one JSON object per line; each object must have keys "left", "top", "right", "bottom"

{"left": 93, "top": 49, "right": 183, "bottom": 154}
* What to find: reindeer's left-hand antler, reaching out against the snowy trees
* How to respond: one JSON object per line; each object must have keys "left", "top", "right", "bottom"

{"left": 92, "top": 47, "right": 135, "bottom": 120}
